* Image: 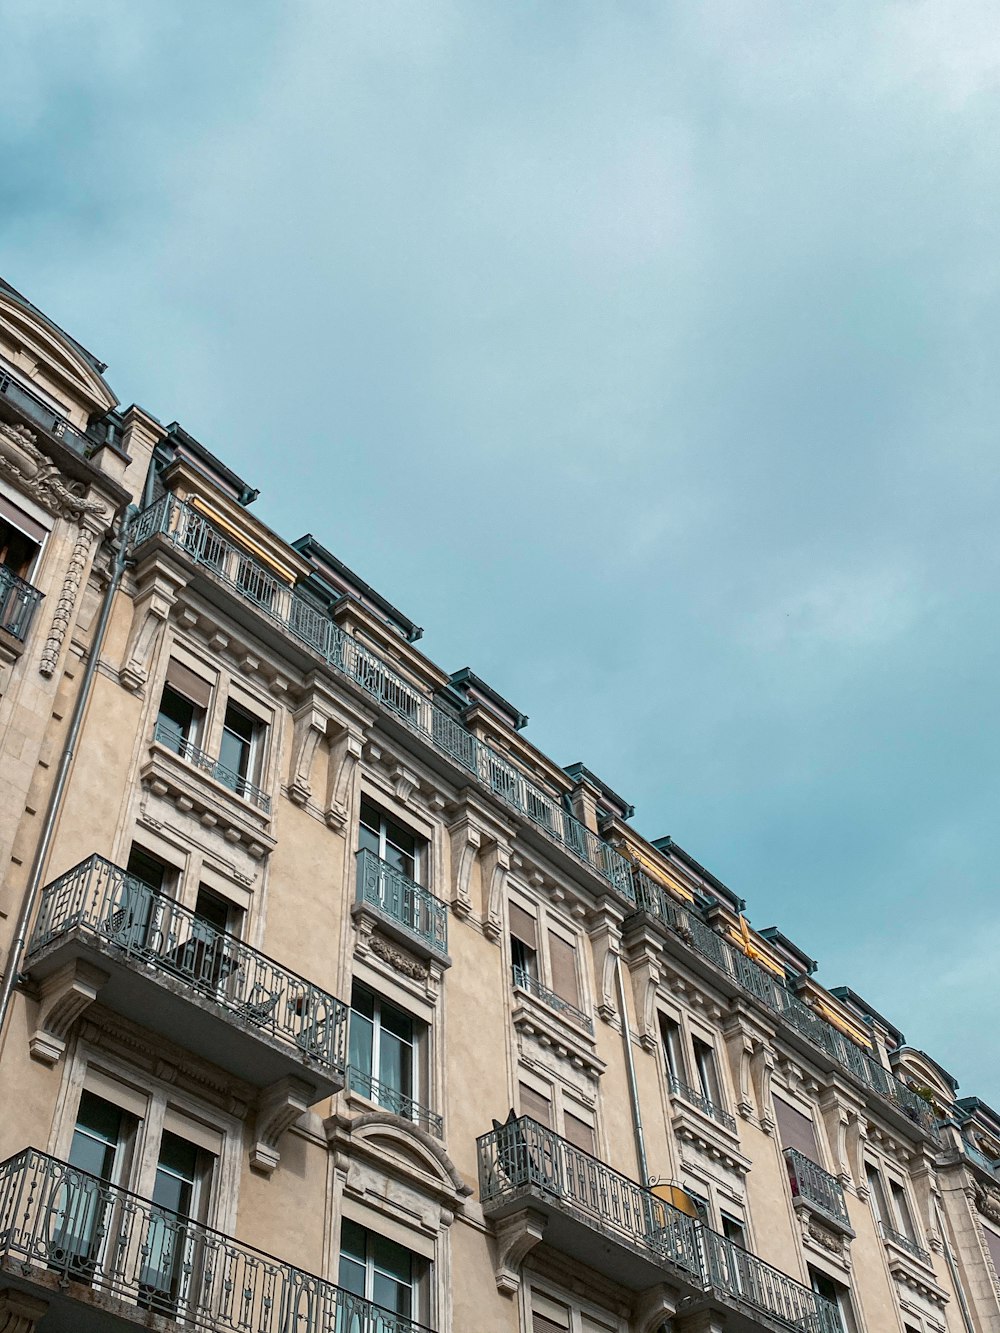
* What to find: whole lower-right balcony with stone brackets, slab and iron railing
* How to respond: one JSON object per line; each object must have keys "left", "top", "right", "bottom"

{"left": 479, "top": 1116, "right": 841, "bottom": 1333}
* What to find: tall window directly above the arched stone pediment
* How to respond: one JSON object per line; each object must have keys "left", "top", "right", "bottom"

{"left": 349, "top": 982, "right": 427, "bottom": 1120}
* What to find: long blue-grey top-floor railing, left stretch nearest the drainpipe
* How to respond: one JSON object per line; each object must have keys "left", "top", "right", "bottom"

{"left": 129, "top": 495, "right": 635, "bottom": 902}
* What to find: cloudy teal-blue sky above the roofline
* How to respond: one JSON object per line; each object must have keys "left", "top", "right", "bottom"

{"left": 0, "top": 0, "right": 1000, "bottom": 1106}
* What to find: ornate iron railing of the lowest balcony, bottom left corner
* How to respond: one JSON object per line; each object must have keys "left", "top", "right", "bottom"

{"left": 0, "top": 1148, "right": 431, "bottom": 1333}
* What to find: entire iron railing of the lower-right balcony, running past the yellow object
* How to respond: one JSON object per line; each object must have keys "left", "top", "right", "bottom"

{"left": 477, "top": 1116, "right": 841, "bottom": 1333}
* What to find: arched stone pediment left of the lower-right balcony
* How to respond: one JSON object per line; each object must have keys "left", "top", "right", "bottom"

{"left": 325, "top": 1112, "right": 472, "bottom": 1214}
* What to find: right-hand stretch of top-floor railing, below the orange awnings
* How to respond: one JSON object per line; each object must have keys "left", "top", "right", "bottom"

{"left": 680, "top": 912, "right": 937, "bottom": 1138}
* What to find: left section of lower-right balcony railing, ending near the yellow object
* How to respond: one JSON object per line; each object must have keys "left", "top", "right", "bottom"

{"left": 477, "top": 1116, "right": 700, "bottom": 1280}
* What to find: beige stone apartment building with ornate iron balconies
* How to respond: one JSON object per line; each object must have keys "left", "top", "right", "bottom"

{"left": 0, "top": 275, "right": 1000, "bottom": 1333}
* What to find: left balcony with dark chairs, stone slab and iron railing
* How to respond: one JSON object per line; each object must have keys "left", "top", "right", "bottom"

{"left": 25, "top": 856, "right": 347, "bottom": 1101}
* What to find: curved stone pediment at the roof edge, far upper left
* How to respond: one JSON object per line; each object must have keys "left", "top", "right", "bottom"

{"left": 0, "top": 287, "right": 117, "bottom": 429}
